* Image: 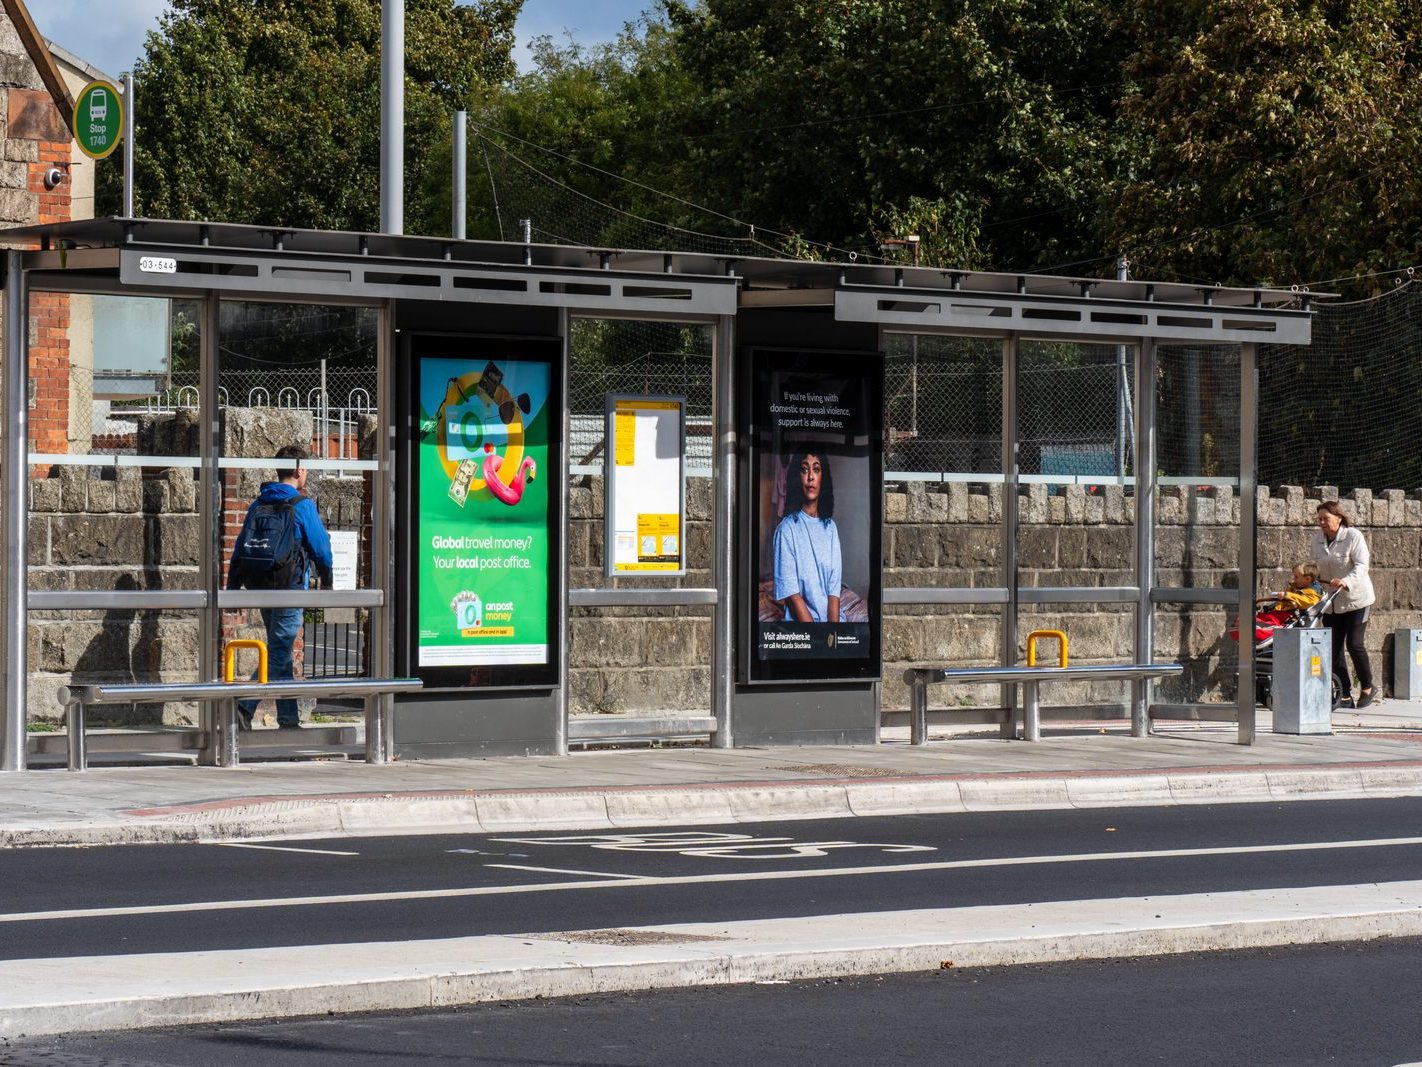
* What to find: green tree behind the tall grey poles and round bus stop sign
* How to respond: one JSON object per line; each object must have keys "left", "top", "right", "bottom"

{"left": 101, "top": 0, "right": 522, "bottom": 230}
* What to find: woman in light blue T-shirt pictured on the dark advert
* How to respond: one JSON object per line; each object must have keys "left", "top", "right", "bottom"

{"left": 772, "top": 451, "right": 843, "bottom": 622}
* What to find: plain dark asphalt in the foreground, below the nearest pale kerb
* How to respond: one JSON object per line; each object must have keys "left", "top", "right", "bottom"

{"left": 11, "top": 940, "right": 1422, "bottom": 1067}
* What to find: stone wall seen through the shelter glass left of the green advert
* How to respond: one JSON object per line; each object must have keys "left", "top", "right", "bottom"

{"left": 28, "top": 408, "right": 371, "bottom": 724}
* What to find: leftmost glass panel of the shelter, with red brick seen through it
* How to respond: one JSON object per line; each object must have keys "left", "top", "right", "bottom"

{"left": 26, "top": 292, "right": 203, "bottom": 767}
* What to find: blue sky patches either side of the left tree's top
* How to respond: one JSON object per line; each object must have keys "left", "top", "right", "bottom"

{"left": 27, "top": 0, "right": 650, "bottom": 77}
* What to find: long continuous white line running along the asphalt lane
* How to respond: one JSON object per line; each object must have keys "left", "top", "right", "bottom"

{"left": 8, "top": 837, "right": 1422, "bottom": 922}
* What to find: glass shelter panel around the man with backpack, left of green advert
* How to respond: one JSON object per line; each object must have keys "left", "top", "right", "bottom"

{"left": 211, "top": 300, "right": 381, "bottom": 743}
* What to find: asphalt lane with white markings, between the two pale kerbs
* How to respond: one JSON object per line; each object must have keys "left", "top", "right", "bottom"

{"left": 8, "top": 798, "right": 1422, "bottom": 959}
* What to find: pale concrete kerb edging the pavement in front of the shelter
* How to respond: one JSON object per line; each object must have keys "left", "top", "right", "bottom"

{"left": 8, "top": 764, "right": 1422, "bottom": 846}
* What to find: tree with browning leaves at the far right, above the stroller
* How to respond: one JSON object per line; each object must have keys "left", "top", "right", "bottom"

{"left": 1103, "top": 0, "right": 1422, "bottom": 293}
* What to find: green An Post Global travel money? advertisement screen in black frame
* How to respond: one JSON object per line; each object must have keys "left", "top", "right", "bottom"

{"left": 412, "top": 344, "right": 559, "bottom": 686}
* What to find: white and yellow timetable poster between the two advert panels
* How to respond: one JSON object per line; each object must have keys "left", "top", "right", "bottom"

{"left": 606, "top": 397, "right": 685, "bottom": 575}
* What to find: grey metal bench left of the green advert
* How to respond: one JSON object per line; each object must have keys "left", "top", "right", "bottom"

{"left": 58, "top": 679, "right": 424, "bottom": 771}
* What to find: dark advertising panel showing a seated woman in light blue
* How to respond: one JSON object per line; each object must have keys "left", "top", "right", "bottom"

{"left": 739, "top": 349, "right": 883, "bottom": 683}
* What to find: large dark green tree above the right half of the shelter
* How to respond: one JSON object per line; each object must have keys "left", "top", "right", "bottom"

{"left": 668, "top": 0, "right": 1128, "bottom": 269}
